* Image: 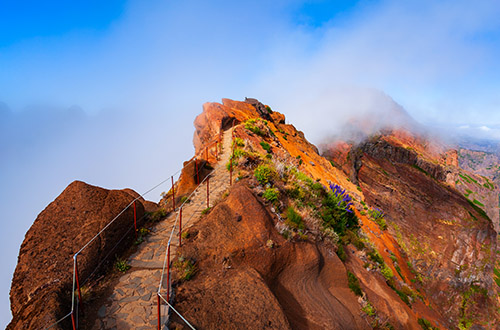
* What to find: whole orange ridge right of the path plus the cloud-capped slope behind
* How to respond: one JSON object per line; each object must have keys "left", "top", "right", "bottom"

{"left": 8, "top": 99, "right": 500, "bottom": 329}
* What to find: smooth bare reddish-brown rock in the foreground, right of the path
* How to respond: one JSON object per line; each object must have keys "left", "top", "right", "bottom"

{"left": 172, "top": 182, "right": 371, "bottom": 329}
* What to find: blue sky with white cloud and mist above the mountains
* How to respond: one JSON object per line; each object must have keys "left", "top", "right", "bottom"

{"left": 0, "top": 0, "right": 500, "bottom": 326}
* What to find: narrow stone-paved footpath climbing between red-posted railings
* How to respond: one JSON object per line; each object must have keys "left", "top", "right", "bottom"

{"left": 92, "top": 129, "right": 232, "bottom": 330}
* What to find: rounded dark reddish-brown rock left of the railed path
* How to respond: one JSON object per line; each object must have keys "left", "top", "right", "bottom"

{"left": 7, "top": 181, "right": 144, "bottom": 329}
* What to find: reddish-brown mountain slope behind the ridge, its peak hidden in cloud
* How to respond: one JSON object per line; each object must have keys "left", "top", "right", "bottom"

{"left": 325, "top": 131, "right": 498, "bottom": 328}
